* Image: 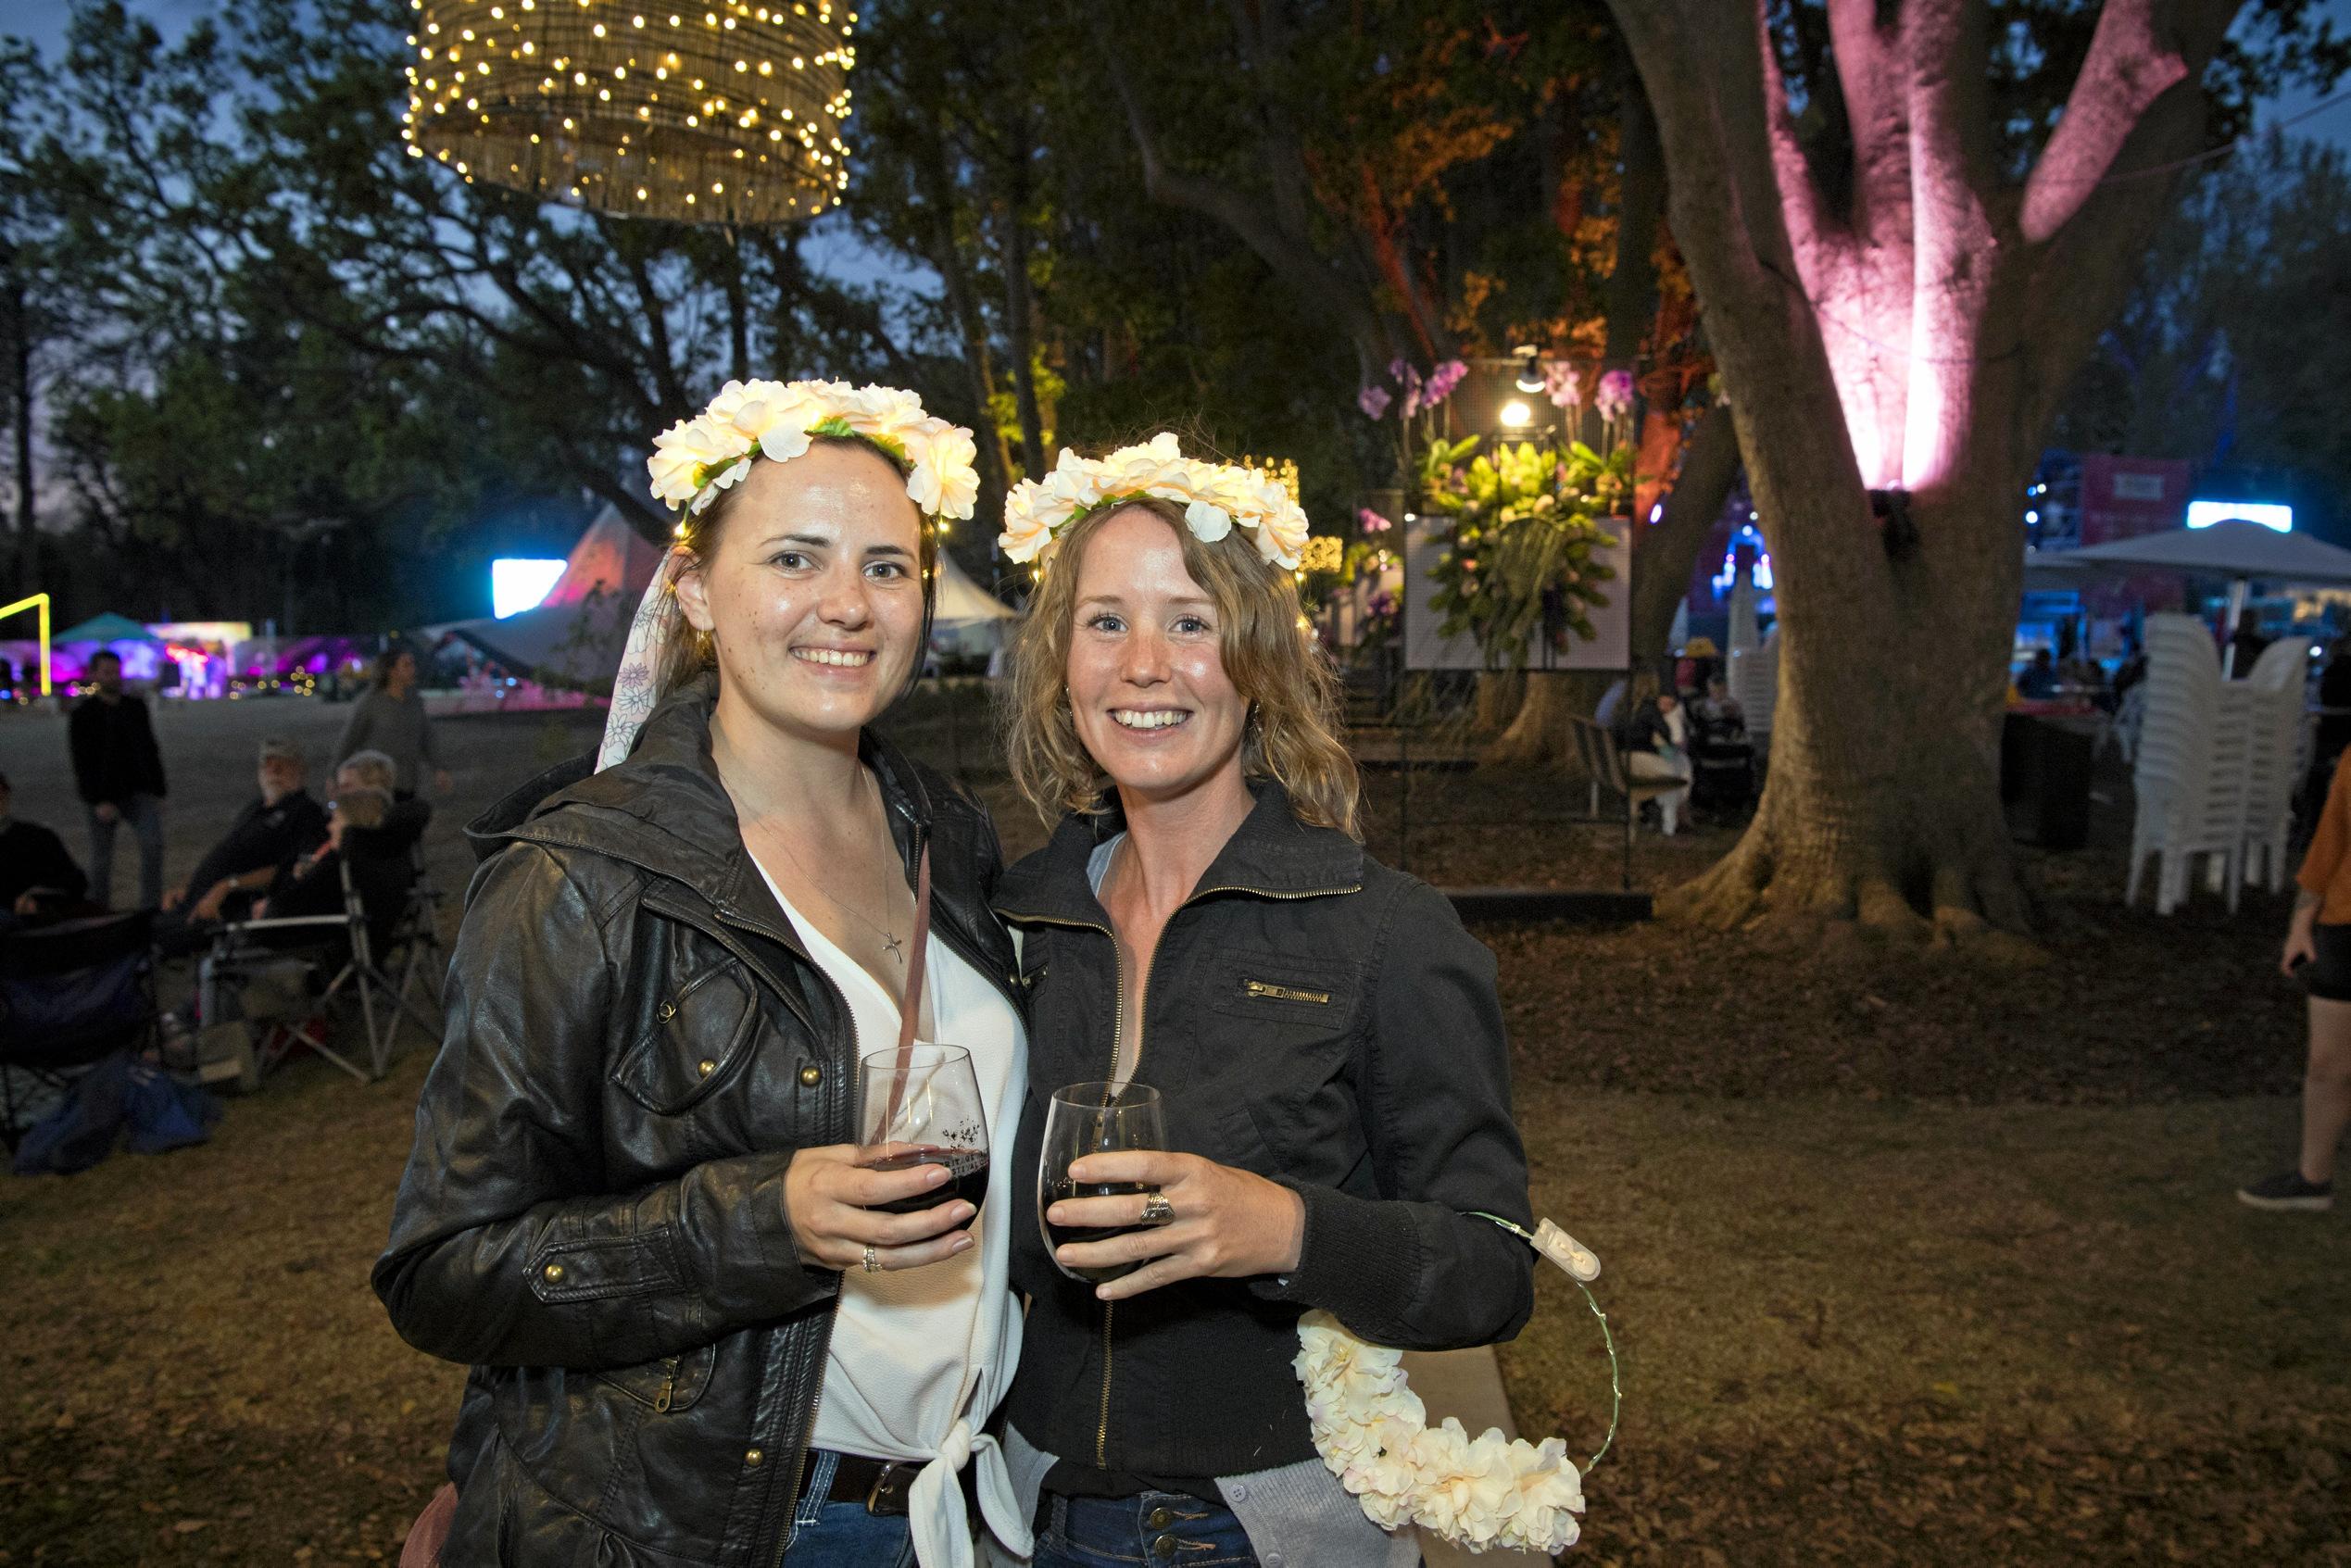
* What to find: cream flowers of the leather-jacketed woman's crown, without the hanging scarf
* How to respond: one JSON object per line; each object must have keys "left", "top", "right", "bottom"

{"left": 644, "top": 381, "right": 980, "bottom": 520}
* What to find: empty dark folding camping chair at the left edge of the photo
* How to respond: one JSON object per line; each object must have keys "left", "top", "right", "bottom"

{"left": 0, "top": 909, "right": 157, "bottom": 1149}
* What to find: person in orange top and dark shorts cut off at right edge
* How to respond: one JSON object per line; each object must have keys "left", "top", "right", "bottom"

{"left": 2236, "top": 761, "right": 2351, "bottom": 1210}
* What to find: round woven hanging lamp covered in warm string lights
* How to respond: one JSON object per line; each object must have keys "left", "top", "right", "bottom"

{"left": 399, "top": 0, "right": 858, "bottom": 223}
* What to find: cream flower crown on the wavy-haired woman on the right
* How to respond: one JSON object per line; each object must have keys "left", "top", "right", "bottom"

{"left": 997, "top": 430, "right": 1307, "bottom": 571}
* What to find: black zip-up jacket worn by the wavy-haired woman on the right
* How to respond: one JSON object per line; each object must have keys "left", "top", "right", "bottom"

{"left": 995, "top": 783, "right": 1533, "bottom": 1476}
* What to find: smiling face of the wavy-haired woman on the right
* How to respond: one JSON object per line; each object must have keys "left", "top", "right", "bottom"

{"left": 1070, "top": 508, "right": 1249, "bottom": 799}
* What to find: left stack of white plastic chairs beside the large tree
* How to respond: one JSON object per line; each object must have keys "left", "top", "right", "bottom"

{"left": 2123, "top": 616, "right": 2250, "bottom": 914}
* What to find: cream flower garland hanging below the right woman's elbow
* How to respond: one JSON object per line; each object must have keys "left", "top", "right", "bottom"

{"left": 1293, "top": 1311, "right": 1585, "bottom": 1556}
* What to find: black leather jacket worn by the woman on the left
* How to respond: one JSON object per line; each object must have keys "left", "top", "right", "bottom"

{"left": 374, "top": 680, "right": 1018, "bottom": 1568}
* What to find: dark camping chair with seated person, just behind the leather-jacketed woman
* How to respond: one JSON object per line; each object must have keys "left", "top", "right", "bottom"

{"left": 207, "top": 825, "right": 440, "bottom": 1084}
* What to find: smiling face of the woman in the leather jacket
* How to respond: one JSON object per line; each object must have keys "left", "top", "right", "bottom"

{"left": 677, "top": 442, "right": 922, "bottom": 738}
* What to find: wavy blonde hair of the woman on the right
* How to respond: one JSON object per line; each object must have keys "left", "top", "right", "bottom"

{"left": 1004, "top": 496, "right": 1362, "bottom": 837}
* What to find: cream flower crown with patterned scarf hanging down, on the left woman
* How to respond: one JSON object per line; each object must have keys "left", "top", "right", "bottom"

{"left": 597, "top": 381, "right": 980, "bottom": 771}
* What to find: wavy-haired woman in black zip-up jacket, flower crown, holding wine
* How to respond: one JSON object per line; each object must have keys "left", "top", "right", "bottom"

{"left": 995, "top": 435, "right": 1533, "bottom": 1568}
